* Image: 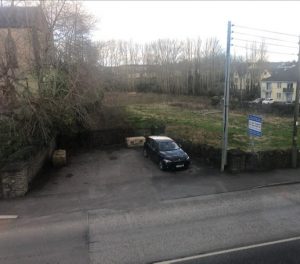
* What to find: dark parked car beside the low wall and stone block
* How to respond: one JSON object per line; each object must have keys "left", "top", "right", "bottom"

{"left": 144, "top": 136, "right": 190, "bottom": 170}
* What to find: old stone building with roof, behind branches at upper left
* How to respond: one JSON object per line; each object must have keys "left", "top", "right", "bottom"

{"left": 0, "top": 6, "right": 53, "bottom": 102}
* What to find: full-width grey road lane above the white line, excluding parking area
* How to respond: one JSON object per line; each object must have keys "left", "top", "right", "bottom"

{"left": 0, "top": 185, "right": 300, "bottom": 264}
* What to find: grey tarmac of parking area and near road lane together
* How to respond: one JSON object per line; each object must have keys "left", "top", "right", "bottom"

{"left": 0, "top": 148, "right": 300, "bottom": 264}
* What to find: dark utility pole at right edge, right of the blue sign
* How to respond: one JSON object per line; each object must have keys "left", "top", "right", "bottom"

{"left": 292, "top": 36, "right": 300, "bottom": 168}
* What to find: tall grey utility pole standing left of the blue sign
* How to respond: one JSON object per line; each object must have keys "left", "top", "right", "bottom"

{"left": 221, "top": 21, "right": 231, "bottom": 171}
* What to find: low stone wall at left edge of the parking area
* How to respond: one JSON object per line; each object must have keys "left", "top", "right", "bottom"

{"left": 0, "top": 139, "right": 56, "bottom": 198}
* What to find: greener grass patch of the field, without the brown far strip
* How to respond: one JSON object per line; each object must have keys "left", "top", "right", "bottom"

{"left": 125, "top": 103, "right": 300, "bottom": 151}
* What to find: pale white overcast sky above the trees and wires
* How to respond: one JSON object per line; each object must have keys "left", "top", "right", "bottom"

{"left": 84, "top": 1, "right": 300, "bottom": 61}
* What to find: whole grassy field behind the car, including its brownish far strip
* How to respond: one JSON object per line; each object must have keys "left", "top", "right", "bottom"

{"left": 104, "top": 93, "right": 300, "bottom": 151}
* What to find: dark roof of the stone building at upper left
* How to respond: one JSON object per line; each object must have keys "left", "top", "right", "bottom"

{"left": 0, "top": 6, "right": 46, "bottom": 28}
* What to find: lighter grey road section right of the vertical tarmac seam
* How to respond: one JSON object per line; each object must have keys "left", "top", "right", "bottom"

{"left": 89, "top": 186, "right": 300, "bottom": 263}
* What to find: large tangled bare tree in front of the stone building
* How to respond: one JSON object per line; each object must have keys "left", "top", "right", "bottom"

{"left": 0, "top": 0, "right": 102, "bottom": 160}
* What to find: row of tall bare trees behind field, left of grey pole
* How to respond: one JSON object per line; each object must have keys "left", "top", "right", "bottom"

{"left": 99, "top": 38, "right": 224, "bottom": 95}
